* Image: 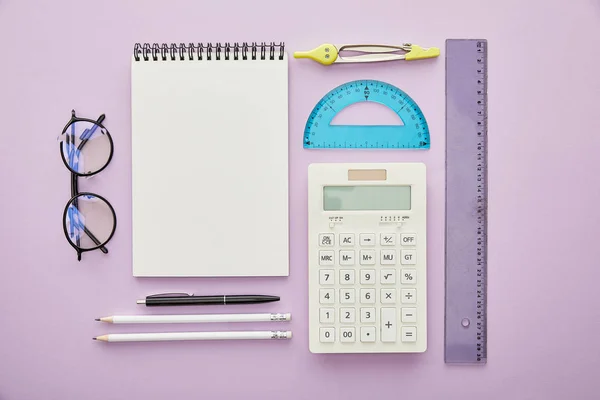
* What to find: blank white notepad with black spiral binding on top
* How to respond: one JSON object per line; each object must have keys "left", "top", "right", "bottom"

{"left": 131, "top": 43, "right": 289, "bottom": 277}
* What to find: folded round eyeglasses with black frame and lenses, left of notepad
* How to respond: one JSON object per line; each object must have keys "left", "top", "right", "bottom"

{"left": 58, "top": 110, "right": 117, "bottom": 261}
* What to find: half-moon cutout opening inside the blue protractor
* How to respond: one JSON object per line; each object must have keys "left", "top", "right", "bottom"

{"left": 331, "top": 101, "right": 404, "bottom": 125}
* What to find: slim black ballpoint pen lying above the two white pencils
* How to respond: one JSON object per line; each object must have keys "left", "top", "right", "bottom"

{"left": 137, "top": 293, "right": 279, "bottom": 307}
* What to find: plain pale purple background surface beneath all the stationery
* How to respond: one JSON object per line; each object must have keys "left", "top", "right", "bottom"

{"left": 0, "top": 0, "right": 600, "bottom": 400}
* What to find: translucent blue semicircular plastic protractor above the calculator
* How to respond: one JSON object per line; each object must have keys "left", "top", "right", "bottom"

{"left": 304, "top": 80, "right": 430, "bottom": 149}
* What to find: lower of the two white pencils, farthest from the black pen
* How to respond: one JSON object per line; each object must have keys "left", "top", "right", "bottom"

{"left": 92, "top": 331, "right": 292, "bottom": 342}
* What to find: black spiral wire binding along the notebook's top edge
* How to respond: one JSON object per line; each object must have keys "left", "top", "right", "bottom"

{"left": 133, "top": 42, "right": 285, "bottom": 61}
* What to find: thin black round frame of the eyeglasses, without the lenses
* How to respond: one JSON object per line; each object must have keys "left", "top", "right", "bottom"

{"left": 59, "top": 110, "right": 117, "bottom": 261}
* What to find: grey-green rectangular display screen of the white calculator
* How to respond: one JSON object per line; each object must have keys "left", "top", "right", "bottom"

{"left": 323, "top": 185, "right": 410, "bottom": 211}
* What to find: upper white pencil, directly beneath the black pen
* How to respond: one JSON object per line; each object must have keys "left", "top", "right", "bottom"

{"left": 96, "top": 313, "right": 292, "bottom": 324}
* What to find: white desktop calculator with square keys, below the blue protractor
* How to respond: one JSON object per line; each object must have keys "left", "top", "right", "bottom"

{"left": 308, "top": 163, "right": 427, "bottom": 353}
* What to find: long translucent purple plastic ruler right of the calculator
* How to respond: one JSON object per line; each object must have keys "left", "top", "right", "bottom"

{"left": 445, "top": 39, "right": 488, "bottom": 364}
